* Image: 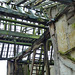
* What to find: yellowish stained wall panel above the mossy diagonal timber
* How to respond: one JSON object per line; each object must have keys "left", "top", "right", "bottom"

{"left": 56, "top": 15, "right": 75, "bottom": 52}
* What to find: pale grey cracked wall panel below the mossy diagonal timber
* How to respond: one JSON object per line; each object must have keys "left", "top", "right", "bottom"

{"left": 59, "top": 56, "right": 75, "bottom": 75}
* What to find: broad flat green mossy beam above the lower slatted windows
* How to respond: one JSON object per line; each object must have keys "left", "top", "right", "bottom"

{"left": 0, "top": 30, "right": 39, "bottom": 39}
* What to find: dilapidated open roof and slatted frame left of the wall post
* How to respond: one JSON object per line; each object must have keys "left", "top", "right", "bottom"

{"left": 0, "top": 0, "right": 74, "bottom": 75}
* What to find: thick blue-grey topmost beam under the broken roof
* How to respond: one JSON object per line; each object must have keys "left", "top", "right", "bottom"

{"left": 0, "top": 7, "right": 48, "bottom": 25}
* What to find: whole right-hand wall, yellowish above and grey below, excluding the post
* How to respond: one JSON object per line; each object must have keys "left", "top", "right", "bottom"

{"left": 55, "top": 8, "right": 75, "bottom": 75}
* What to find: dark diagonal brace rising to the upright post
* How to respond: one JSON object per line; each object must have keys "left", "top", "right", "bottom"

{"left": 13, "top": 30, "right": 50, "bottom": 60}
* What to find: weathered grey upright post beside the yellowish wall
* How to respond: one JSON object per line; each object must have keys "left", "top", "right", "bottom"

{"left": 49, "top": 23, "right": 60, "bottom": 75}
